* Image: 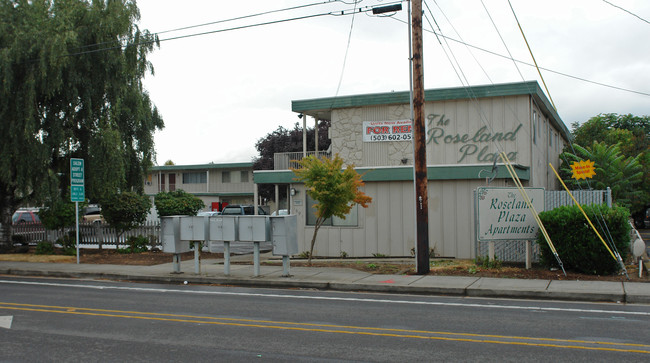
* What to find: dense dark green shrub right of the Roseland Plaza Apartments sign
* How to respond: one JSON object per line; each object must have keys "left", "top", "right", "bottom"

{"left": 537, "top": 205, "right": 630, "bottom": 275}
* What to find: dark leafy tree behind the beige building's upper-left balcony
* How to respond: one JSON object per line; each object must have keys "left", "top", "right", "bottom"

{"left": 253, "top": 120, "right": 331, "bottom": 199}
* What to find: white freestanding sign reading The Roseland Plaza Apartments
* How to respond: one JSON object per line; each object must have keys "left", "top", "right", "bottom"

{"left": 476, "top": 187, "right": 544, "bottom": 241}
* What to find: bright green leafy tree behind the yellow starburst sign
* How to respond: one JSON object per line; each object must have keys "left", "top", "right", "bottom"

{"left": 560, "top": 142, "right": 643, "bottom": 209}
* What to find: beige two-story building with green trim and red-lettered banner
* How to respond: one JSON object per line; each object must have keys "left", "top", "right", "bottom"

{"left": 254, "top": 81, "right": 569, "bottom": 258}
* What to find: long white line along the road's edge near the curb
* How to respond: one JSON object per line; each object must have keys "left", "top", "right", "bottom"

{"left": 0, "top": 280, "right": 650, "bottom": 316}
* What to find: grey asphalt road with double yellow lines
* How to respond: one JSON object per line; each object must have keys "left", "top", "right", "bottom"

{"left": 0, "top": 276, "right": 650, "bottom": 362}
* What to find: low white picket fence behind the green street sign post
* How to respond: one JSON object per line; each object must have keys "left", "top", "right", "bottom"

{"left": 12, "top": 221, "right": 160, "bottom": 248}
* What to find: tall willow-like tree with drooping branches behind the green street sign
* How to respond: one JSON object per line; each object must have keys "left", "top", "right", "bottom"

{"left": 0, "top": 0, "right": 163, "bottom": 247}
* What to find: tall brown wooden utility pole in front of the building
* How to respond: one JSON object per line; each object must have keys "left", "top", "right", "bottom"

{"left": 411, "top": 0, "right": 430, "bottom": 275}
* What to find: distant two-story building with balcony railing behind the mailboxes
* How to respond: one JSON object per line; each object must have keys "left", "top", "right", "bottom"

{"left": 144, "top": 162, "right": 254, "bottom": 216}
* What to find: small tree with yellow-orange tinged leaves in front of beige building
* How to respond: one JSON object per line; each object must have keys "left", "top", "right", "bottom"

{"left": 291, "top": 154, "right": 372, "bottom": 264}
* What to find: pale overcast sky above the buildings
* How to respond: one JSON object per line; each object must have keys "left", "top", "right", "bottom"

{"left": 137, "top": 0, "right": 650, "bottom": 165}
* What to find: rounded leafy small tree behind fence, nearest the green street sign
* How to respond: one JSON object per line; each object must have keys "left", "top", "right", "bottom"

{"left": 102, "top": 192, "right": 151, "bottom": 246}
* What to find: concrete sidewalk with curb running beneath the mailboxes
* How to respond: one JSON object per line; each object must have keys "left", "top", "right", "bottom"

{"left": 0, "top": 255, "right": 650, "bottom": 304}
